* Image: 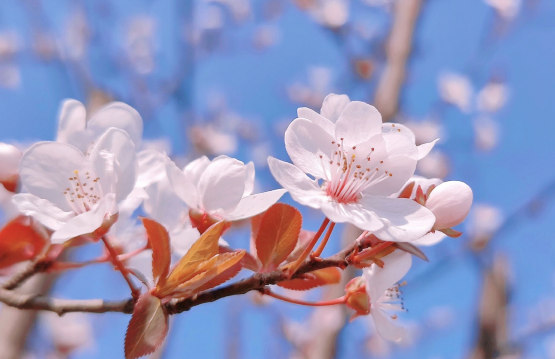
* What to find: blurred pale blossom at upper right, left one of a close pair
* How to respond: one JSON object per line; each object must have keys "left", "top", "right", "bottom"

{"left": 438, "top": 73, "right": 473, "bottom": 112}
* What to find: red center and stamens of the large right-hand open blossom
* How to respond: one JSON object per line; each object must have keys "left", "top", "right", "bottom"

{"left": 320, "top": 138, "right": 393, "bottom": 203}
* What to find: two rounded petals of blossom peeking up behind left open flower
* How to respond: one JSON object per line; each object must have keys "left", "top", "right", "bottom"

{"left": 56, "top": 100, "right": 143, "bottom": 154}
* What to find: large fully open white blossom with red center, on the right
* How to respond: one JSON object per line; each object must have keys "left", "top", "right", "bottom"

{"left": 268, "top": 94, "right": 435, "bottom": 241}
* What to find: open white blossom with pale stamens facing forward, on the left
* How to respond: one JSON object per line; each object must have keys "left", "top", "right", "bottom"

{"left": 13, "top": 128, "right": 137, "bottom": 243}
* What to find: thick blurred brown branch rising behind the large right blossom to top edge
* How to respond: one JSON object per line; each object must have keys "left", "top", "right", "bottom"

{"left": 374, "top": 0, "right": 422, "bottom": 121}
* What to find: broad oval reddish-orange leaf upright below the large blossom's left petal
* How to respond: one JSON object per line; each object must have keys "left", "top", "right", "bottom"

{"left": 255, "top": 203, "right": 303, "bottom": 270}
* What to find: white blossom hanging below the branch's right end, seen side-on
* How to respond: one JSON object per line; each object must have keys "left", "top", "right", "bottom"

{"left": 362, "top": 250, "right": 412, "bottom": 342}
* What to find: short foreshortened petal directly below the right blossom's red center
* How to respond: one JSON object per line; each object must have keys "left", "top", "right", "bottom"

{"left": 321, "top": 201, "right": 383, "bottom": 231}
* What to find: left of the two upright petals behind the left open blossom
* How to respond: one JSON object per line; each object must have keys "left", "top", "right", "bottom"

{"left": 56, "top": 100, "right": 90, "bottom": 152}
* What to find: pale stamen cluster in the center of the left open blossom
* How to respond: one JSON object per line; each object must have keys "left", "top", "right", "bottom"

{"left": 64, "top": 170, "right": 103, "bottom": 214}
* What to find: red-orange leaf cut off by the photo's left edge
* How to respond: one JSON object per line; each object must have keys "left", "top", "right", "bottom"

{"left": 0, "top": 216, "right": 48, "bottom": 268}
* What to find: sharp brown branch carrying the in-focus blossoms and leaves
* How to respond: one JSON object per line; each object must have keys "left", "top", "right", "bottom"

{"left": 0, "top": 241, "right": 364, "bottom": 315}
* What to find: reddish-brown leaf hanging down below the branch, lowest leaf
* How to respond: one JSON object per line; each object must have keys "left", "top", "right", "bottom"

{"left": 125, "top": 292, "right": 168, "bottom": 359}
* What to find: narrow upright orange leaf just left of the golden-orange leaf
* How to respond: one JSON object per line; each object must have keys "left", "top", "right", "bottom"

{"left": 141, "top": 218, "right": 171, "bottom": 283}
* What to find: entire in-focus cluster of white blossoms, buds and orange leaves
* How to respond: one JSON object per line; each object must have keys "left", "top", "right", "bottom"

{"left": 0, "top": 94, "right": 473, "bottom": 357}
